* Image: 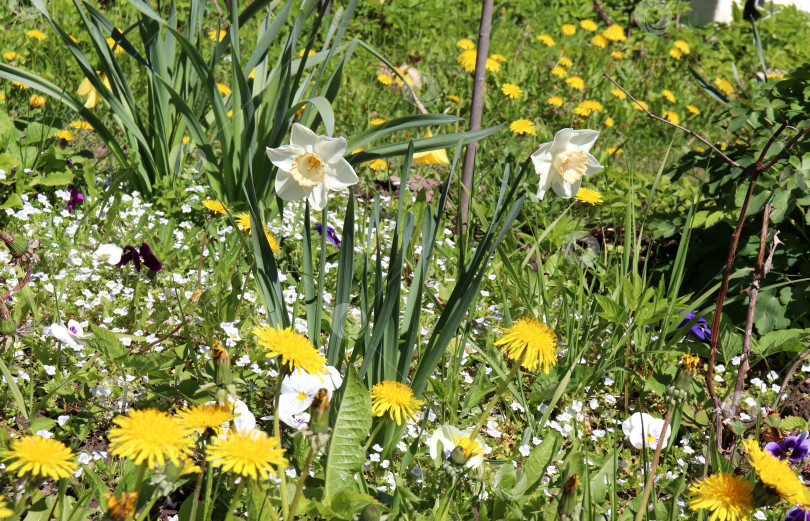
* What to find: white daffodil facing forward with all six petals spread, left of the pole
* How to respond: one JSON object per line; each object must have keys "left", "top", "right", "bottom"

{"left": 267, "top": 123, "right": 358, "bottom": 211}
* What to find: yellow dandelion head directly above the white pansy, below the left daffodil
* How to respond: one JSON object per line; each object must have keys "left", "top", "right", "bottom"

{"left": 253, "top": 325, "right": 327, "bottom": 375}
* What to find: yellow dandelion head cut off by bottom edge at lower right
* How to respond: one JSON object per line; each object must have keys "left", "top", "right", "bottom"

{"left": 689, "top": 474, "right": 754, "bottom": 521}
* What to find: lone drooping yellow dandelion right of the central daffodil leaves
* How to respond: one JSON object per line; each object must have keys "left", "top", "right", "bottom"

{"left": 495, "top": 317, "right": 558, "bottom": 374}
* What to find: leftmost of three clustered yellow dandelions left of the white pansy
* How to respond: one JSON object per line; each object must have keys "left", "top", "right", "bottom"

{"left": 109, "top": 409, "right": 194, "bottom": 468}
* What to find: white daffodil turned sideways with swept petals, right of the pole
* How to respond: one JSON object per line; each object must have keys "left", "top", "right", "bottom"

{"left": 532, "top": 128, "right": 602, "bottom": 200}
